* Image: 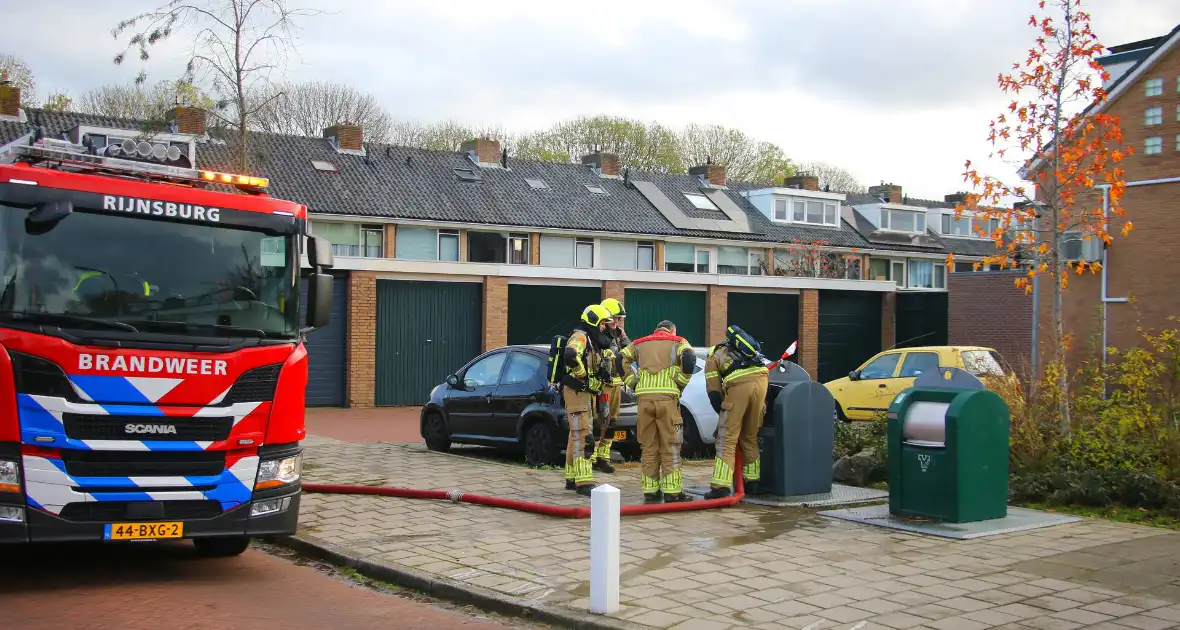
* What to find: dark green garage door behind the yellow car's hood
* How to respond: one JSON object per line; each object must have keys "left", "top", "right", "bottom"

{"left": 813, "top": 291, "right": 883, "bottom": 382}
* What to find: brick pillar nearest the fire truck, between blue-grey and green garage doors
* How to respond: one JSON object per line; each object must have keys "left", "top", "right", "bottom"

{"left": 347, "top": 271, "right": 376, "bottom": 408}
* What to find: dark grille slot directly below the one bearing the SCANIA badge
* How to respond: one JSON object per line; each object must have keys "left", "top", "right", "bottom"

{"left": 61, "top": 451, "right": 225, "bottom": 477}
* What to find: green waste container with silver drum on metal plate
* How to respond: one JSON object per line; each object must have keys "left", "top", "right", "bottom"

{"left": 889, "top": 368, "right": 1010, "bottom": 523}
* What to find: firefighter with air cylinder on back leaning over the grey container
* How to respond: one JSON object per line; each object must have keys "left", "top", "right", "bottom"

{"left": 704, "top": 326, "right": 771, "bottom": 499}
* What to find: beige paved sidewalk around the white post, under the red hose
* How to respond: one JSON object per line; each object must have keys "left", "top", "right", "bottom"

{"left": 302, "top": 438, "right": 1180, "bottom": 630}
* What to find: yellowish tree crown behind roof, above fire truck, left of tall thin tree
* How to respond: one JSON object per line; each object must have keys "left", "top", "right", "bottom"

{"left": 73, "top": 81, "right": 216, "bottom": 120}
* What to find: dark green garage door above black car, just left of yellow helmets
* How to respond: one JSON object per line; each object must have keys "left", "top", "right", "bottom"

{"left": 509, "top": 284, "right": 602, "bottom": 344}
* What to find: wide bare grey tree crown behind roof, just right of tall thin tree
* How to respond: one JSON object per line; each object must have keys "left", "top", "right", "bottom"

{"left": 250, "top": 81, "right": 394, "bottom": 143}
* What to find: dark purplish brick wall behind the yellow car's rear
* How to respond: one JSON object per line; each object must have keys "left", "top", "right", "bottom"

{"left": 946, "top": 271, "right": 1033, "bottom": 376}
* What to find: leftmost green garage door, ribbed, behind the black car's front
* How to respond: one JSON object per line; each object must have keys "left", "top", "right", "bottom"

{"left": 374, "top": 280, "right": 484, "bottom": 406}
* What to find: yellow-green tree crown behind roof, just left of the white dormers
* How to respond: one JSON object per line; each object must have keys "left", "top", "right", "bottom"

{"left": 680, "top": 124, "right": 794, "bottom": 184}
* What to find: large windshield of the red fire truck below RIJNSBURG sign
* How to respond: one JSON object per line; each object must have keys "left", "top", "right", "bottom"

{"left": 0, "top": 204, "right": 299, "bottom": 337}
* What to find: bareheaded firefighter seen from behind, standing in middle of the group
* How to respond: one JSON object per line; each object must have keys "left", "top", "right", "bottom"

{"left": 622, "top": 320, "right": 696, "bottom": 503}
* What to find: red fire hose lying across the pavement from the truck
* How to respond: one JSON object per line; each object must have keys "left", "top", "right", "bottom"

{"left": 303, "top": 457, "right": 746, "bottom": 518}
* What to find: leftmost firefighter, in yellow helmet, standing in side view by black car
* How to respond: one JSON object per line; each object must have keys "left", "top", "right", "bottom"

{"left": 562, "top": 304, "right": 610, "bottom": 497}
